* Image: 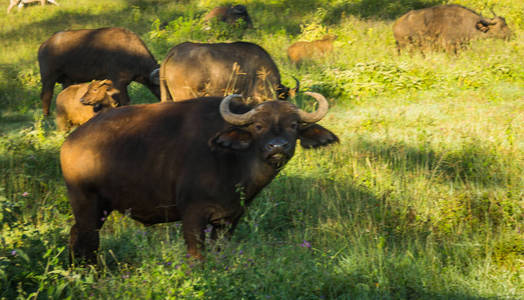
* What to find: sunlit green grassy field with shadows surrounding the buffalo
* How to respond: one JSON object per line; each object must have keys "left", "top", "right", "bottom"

{"left": 0, "top": 0, "right": 524, "bottom": 299}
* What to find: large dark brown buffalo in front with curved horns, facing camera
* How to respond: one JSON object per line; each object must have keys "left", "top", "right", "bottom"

{"left": 60, "top": 93, "right": 338, "bottom": 260}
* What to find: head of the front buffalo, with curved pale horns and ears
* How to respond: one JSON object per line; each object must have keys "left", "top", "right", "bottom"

{"left": 213, "top": 92, "right": 338, "bottom": 170}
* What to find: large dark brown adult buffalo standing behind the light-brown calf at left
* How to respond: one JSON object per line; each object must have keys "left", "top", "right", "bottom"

{"left": 38, "top": 28, "right": 160, "bottom": 115}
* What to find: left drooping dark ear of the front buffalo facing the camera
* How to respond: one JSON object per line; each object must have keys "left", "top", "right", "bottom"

{"left": 208, "top": 127, "right": 253, "bottom": 151}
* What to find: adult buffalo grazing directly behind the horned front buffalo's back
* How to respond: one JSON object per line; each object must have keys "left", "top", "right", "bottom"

{"left": 160, "top": 42, "right": 299, "bottom": 103}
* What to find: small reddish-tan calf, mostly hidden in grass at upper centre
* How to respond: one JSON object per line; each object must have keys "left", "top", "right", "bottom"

{"left": 287, "top": 35, "right": 337, "bottom": 64}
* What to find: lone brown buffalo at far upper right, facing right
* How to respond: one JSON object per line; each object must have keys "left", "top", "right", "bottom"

{"left": 393, "top": 4, "right": 511, "bottom": 53}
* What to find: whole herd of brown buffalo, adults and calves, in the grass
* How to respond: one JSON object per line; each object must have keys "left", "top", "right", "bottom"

{"left": 20, "top": 0, "right": 511, "bottom": 262}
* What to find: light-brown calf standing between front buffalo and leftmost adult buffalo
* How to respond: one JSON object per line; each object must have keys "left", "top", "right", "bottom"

{"left": 56, "top": 80, "right": 118, "bottom": 131}
